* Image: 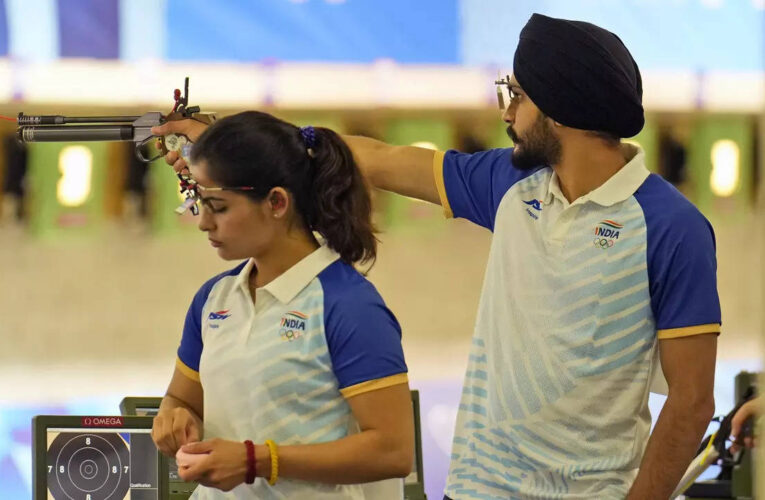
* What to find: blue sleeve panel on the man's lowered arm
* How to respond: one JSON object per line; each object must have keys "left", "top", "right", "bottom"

{"left": 635, "top": 174, "right": 721, "bottom": 330}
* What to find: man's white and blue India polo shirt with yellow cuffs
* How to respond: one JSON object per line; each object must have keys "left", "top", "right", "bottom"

{"left": 434, "top": 146, "right": 720, "bottom": 500}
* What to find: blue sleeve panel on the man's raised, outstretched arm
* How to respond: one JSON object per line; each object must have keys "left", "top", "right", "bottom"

{"left": 443, "top": 148, "right": 543, "bottom": 231}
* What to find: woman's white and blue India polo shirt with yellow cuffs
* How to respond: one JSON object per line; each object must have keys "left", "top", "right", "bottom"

{"left": 177, "top": 246, "right": 407, "bottom": 499}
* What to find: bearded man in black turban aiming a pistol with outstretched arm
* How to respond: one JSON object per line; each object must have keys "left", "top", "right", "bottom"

{"left": 155, "top": 15, "right": 720, "bottom": 500}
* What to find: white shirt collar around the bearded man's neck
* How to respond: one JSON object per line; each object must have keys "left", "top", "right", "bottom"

{"left": 544, "top": 143, "right": 650, "bottom": 207}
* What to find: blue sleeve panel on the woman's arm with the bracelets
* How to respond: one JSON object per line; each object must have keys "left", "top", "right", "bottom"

{"left": 319, "top": 260, "right": 407, "bottom": 389}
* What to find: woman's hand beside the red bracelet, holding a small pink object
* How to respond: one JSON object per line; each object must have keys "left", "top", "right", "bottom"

{"left": 178, "top": 438, "right": 247, "bottom": 491}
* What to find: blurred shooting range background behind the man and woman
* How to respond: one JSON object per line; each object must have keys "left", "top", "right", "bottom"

{"left": 0, "top": 0, "right": 765, "bottom": 498}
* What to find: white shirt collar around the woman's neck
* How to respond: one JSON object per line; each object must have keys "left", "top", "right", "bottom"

{"left": 237, "top": 245, "right": 340, "bottom": 304}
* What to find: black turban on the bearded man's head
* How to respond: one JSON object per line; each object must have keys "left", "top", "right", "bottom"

{"left": 513, "top": 14, "right": 645, "bottom": 137}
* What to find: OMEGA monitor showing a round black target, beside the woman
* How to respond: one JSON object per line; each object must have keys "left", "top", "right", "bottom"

{"left": 34, "top": 417, "right": 161, "bottom": 500}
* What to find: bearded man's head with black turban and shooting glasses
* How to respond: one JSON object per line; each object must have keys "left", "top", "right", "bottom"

{"left": 504, "top": 14, "right": 645, "bottom": 178}
